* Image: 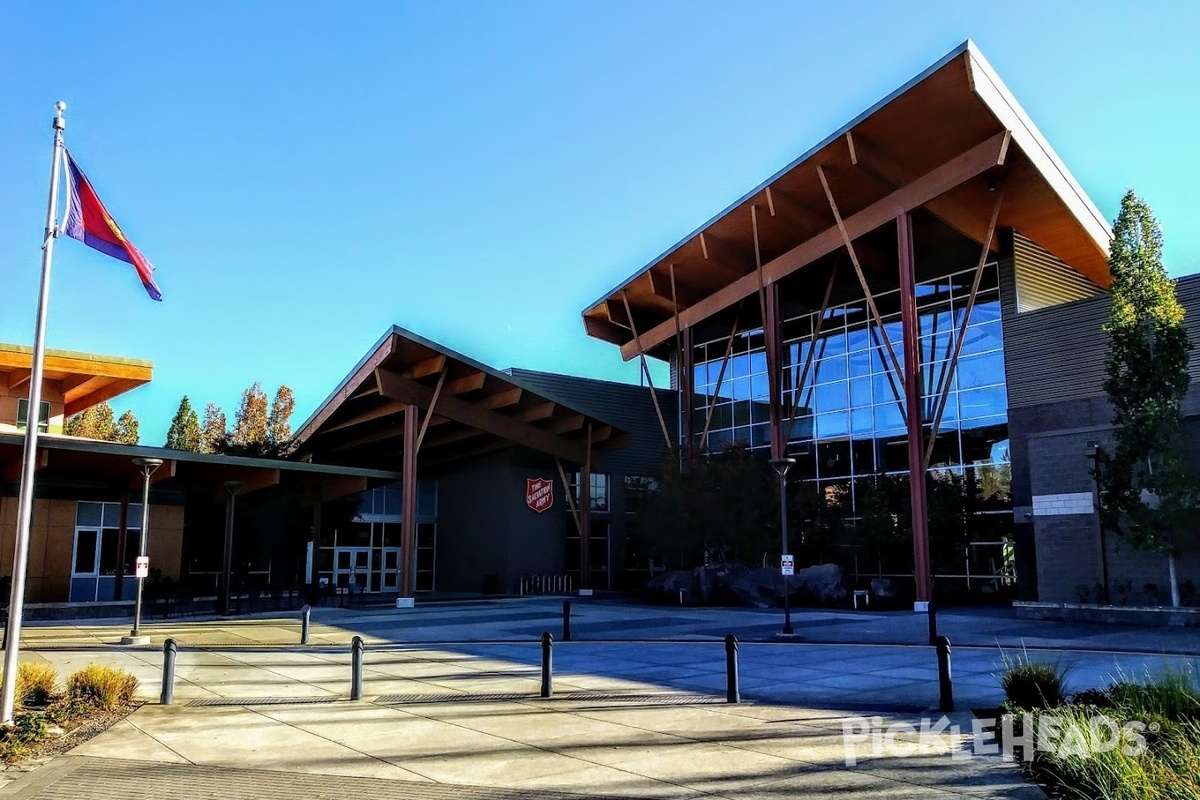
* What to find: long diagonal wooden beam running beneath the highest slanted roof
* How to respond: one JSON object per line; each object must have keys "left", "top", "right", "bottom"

{"left": 620, "top": 131, "right": 1009, "bottom": 361}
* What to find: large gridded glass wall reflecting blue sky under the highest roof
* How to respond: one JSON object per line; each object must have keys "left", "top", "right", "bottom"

{"left": 694, "top": 264, "right": 1012, "bottom": 589}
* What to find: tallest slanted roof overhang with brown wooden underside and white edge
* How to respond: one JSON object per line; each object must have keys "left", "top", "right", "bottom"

{"left": 583, "top": 41, "right": 1111, "bottom": 360}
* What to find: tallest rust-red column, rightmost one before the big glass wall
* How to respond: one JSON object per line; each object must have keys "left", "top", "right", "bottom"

{"left": 896, "top": 213, "right": 932, "bottom": 604}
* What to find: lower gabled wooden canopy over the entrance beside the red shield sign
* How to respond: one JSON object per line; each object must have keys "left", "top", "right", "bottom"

{"left": 296, "top": 326, "right": 626, "bottom": 470}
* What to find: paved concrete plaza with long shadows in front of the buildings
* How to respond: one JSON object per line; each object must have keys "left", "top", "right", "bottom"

{"left": 0, "top": 599, "right": 1190, "bottom": 799}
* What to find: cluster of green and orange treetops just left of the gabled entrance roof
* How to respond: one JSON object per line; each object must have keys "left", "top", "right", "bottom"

{"left": 167, "top": 380, "right": 295, "bottom": 457}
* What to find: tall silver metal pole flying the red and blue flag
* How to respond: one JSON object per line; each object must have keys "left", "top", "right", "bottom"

{"left": 0, "top": 101, "right": 67, "bottom": 724}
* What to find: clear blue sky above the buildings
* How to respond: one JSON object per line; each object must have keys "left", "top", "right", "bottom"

{"left": 0, "top": 0, "right": 1200, "bottom": 445}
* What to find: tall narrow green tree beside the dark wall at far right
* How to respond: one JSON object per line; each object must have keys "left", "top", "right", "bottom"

{"left": 1096, "top": 191, "right": 1196, "bottom": 606}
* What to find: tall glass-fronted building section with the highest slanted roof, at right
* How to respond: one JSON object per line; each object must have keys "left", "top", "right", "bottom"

{"left": 583, "top": 42, "right": 1200, "bottom": 606}
